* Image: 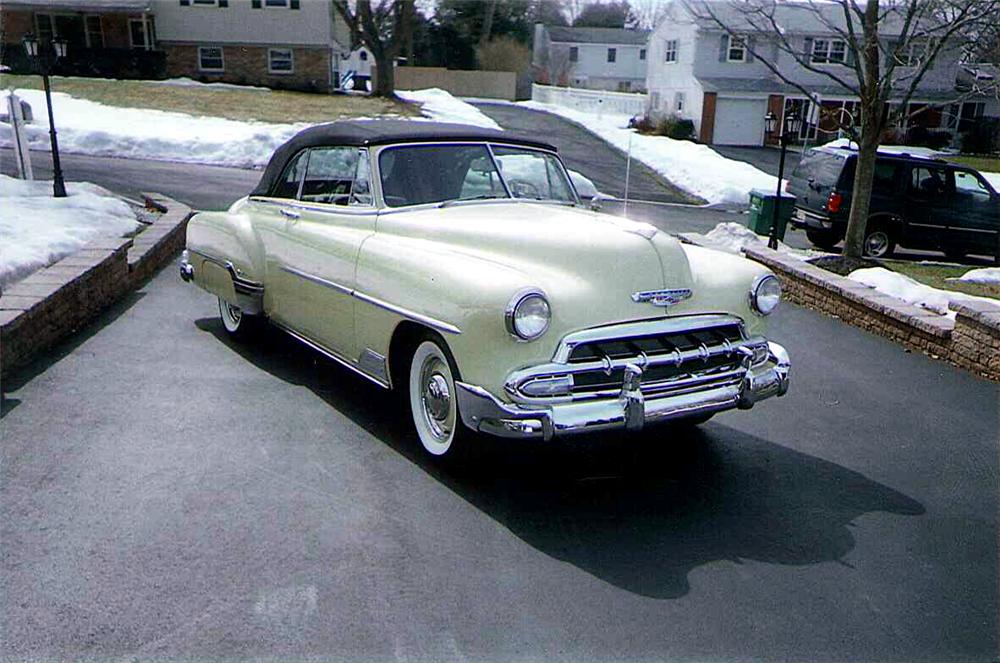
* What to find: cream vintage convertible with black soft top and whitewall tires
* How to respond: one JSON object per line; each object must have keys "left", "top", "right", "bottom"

{"left": 180, "top": 120, "right": 789, "bottom": 456}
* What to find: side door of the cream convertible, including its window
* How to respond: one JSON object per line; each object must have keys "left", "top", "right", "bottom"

{"left": 278, "top": 147, "right": 376, "bottom": 361}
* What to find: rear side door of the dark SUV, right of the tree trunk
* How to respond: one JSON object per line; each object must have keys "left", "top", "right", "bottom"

{"left": 899, "top": 163, "right": 954, "bottom": 249}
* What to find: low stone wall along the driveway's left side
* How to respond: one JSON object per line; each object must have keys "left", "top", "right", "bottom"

{"left": 0, "top": 193, "right": 192, "bottom": 378}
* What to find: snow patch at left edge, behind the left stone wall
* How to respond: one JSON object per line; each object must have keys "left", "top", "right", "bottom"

{"left": 0, "top": 175, "right": 138, "bottom": 288}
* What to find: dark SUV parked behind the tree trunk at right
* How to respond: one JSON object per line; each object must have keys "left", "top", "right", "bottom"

{"left": 787, "top": 147, "right": 1000, "bottom": 262}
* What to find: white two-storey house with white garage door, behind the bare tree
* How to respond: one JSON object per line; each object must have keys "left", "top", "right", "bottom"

{"left": 647, "top": 0, "right": 982, "bottom": 145}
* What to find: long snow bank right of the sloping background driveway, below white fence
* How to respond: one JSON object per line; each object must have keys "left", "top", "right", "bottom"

{"left": 518, "top": 101, "right": 778, "bottom": 207}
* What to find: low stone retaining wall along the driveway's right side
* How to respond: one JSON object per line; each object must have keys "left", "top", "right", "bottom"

{"left": 744, "top": 248, "right": 1000, "bottom": 380}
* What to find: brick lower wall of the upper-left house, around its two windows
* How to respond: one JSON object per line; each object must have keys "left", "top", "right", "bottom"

{"left": 160, "top": 42, "right": 330, "bottom": 92}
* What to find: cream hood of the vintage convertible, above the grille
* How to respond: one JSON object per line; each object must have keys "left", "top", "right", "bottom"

{"left": 379, "top": 201, "right": 692, "bottom": 330}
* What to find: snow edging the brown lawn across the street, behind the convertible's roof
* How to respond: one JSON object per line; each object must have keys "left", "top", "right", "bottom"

{"left": 0, "top": 84, "right": 498, "bottom": 168}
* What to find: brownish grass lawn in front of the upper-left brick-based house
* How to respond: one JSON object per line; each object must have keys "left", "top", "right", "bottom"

{"left": 0, "top": 74, "right": 420, "bottom": 122}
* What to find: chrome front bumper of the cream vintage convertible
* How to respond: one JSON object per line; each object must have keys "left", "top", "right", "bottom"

{"left": 456, "top": 342, "right": 791, "bottom": 440}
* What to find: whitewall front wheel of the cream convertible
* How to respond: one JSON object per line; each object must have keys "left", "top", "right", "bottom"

{"left": 409, "top": 338, "right": 471, "bottom": 461}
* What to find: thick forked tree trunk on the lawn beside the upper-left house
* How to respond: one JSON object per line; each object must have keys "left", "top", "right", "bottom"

{"left": 333, "top": 0, "right": 414, "bottom": 98}
